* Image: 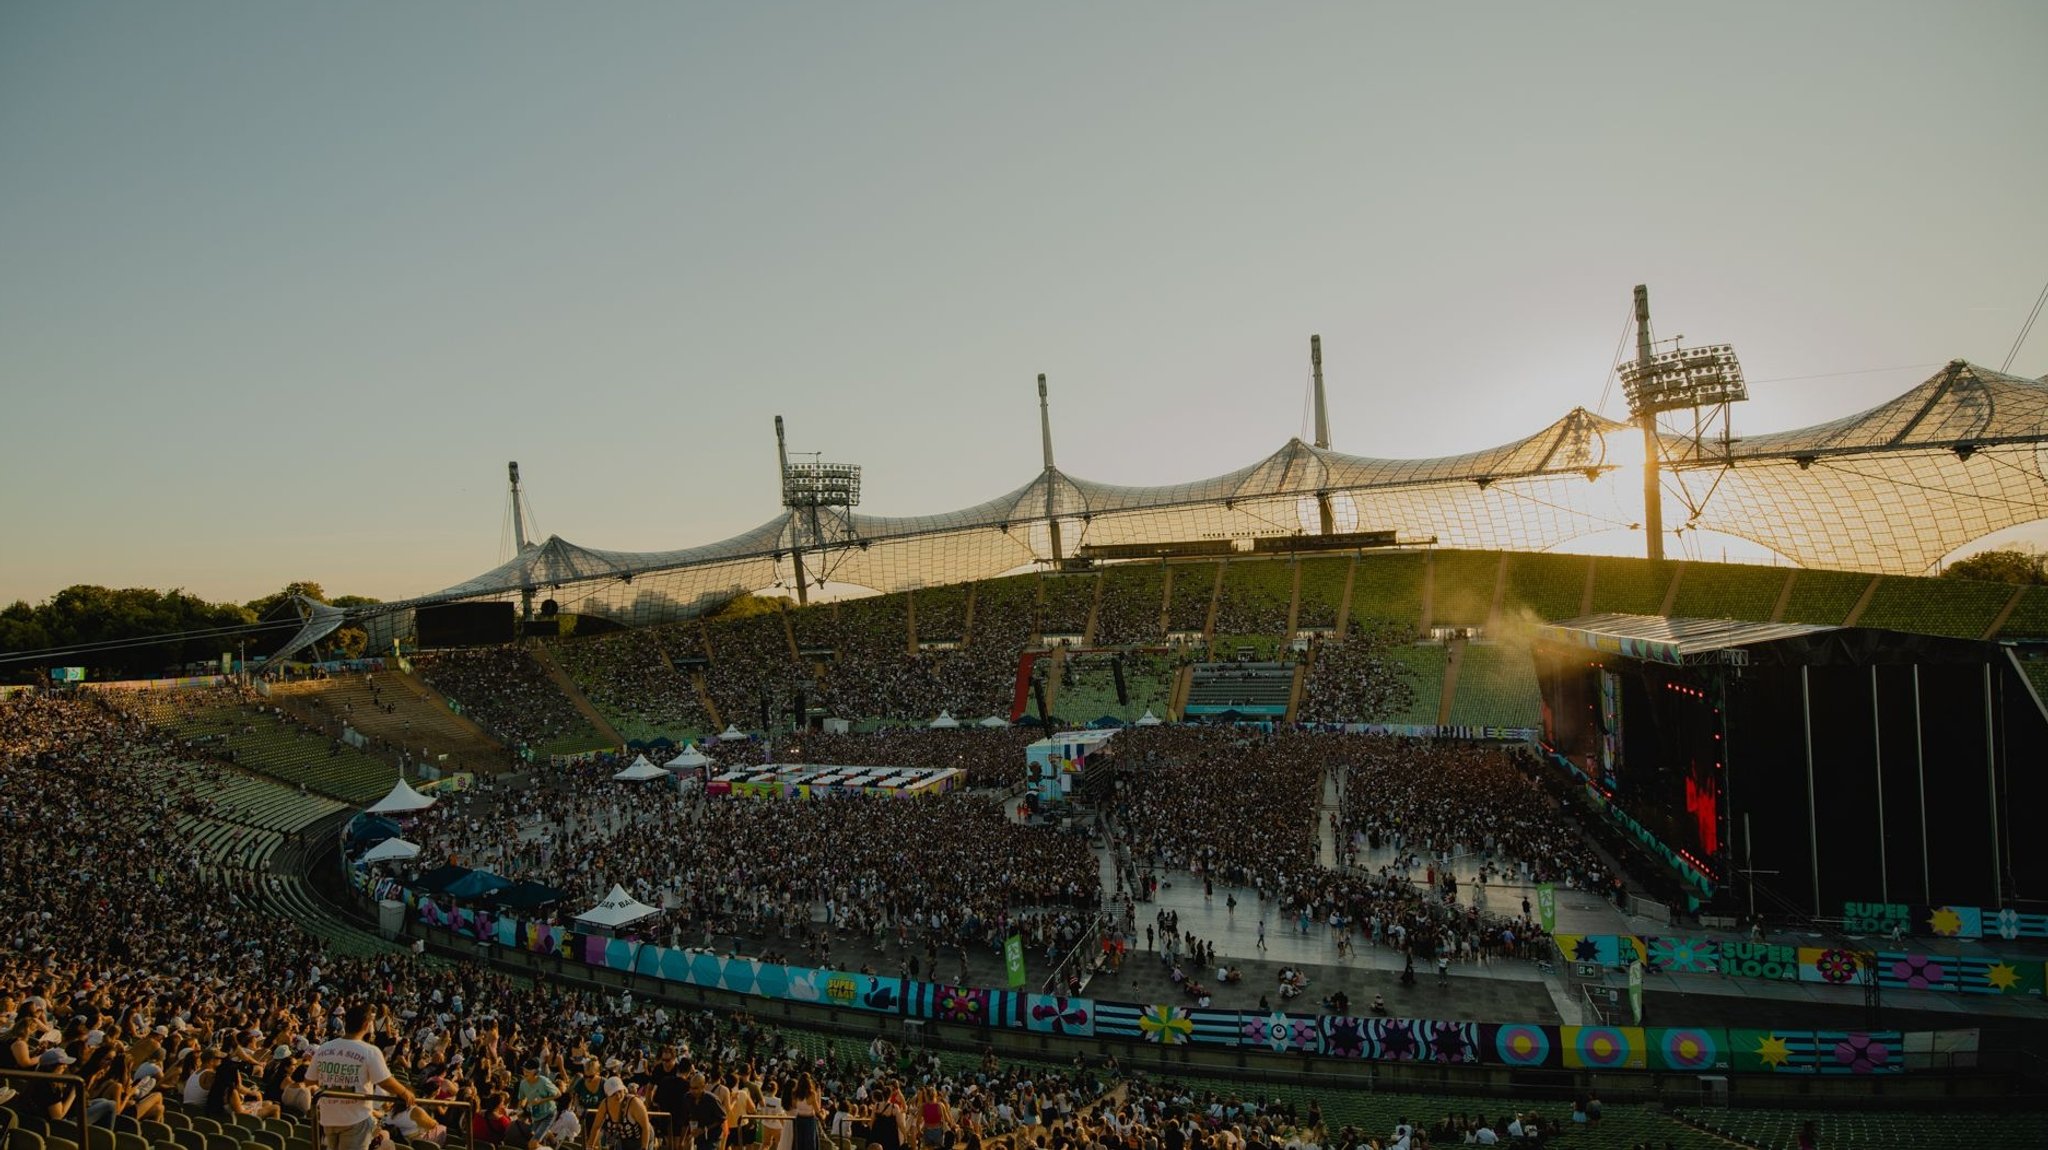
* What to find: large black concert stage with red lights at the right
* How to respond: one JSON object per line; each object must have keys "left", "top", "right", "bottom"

{"left": 1536, "top": 624, "right": 2048, "bottom": 915}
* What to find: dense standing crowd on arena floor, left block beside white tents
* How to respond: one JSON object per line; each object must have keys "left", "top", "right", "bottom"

{"left": 397, "top": 767, "right": 1100, "bottom": 978}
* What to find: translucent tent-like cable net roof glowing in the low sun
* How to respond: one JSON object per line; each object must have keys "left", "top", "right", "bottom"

{"left": 385, "top": 360, "right": 2048, "bottom": 622}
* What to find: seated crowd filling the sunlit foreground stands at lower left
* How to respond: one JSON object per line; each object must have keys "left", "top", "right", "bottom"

{"left": 0, "top": 694, "right": 1163, "bottom": 1150}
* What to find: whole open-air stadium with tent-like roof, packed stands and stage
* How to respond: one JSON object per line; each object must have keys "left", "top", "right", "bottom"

{"left": 0, "top": 289, "right": 2048, "bottom": 1150}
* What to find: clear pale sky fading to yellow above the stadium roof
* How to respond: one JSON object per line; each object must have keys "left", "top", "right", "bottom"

{"left": 0, "top": 0, "right": 2048, "bottom": 602}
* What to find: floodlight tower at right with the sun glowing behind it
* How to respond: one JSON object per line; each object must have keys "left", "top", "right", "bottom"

{"left": 1622, "top": 284, "right": 1749, "bottom": 559}
